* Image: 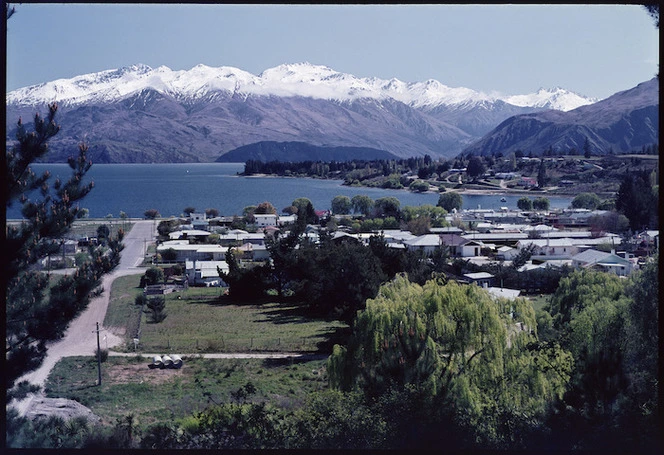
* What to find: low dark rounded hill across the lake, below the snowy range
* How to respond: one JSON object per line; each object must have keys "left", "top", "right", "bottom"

{"left": 216, "top": 141, "right": 397, "bottom": 163}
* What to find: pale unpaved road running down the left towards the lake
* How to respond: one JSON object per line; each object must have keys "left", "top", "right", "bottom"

{"left": 14, "top": 220, "right": 156, "bottom": 415}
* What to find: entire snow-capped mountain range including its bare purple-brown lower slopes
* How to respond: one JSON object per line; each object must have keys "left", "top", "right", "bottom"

{"left": 6, "top": 63, "right": 632, "bottom": 163}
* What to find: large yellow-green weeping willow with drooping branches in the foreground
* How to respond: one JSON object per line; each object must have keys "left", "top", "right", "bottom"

{"left": 328, "top": 276, "right": 572, "bottom": 447}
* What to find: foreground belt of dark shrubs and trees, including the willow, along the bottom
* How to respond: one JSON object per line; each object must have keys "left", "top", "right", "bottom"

{"left": 7, "top": 258, "right": 661, "bottom": 453}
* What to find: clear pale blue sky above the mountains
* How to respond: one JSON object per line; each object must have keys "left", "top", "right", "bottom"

{"left": 7, "top": 3, "right": 659, "bottom": 98}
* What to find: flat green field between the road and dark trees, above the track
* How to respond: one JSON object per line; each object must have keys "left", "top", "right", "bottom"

{"left": 104, "top": 275, "right": 348, "bottom": 354}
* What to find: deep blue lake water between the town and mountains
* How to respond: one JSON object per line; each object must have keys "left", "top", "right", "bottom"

{"left": 7, "top": 163, "right": 572, "bottom": 219}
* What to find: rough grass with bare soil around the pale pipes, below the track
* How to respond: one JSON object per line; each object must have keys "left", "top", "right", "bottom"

{"left": 46, "top": 357, "right": 327, "bottom": 432}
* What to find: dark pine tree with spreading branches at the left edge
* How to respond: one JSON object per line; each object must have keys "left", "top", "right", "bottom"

{"left": 1, "top": 103, "right": 124, "bottom": 389}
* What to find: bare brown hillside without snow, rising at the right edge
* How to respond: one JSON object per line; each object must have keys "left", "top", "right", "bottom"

{"left": 462, "top": 78, "right": 659, "bottom": 155}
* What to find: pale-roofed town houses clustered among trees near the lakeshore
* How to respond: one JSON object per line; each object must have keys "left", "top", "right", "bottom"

{"left": 154, "top": 203, "right": 659, "bottom": 295}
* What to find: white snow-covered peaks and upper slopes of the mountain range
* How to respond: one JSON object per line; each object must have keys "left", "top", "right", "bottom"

{"left": 7, "top": 63, "right": 598, "bottom": 111}
